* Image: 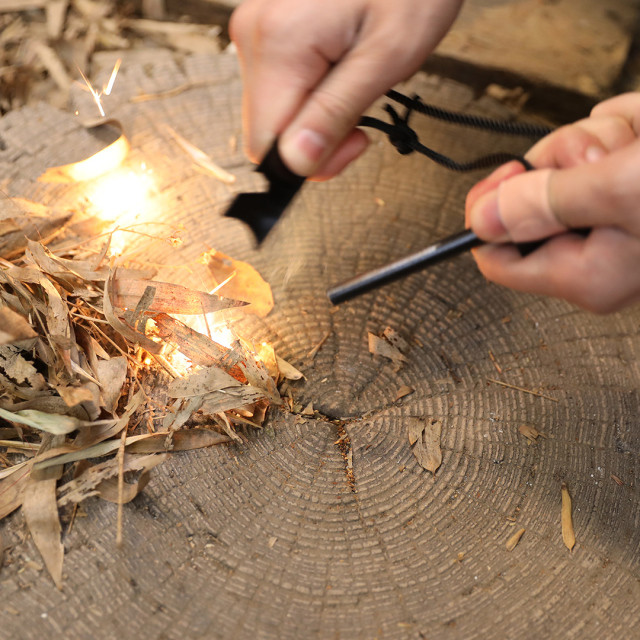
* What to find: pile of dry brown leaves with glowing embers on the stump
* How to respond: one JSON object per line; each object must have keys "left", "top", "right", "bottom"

{"left": 0, "top": 191, "right": 301, "bottom": 585}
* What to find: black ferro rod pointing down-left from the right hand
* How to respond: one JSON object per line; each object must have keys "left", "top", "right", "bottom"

{"left": 327, "top": 229, "right": 483, "bottom": 304}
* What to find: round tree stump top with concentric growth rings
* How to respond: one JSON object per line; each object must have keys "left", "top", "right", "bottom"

{"left": 0, "top": 52, "right": 640, "bottom": 640}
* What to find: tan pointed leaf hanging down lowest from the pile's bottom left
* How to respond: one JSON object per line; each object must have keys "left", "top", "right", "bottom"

{"left": 22, "top": 436, "right": 64, "bottom": 589}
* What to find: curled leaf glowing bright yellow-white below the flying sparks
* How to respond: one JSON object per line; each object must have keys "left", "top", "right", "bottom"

{"left": 38, "top": 119, "right": 129, "bottom": 183}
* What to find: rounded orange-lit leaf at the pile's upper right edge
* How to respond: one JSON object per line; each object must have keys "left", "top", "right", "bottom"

{"left": 203, "top": 251, "right": 273, "bottom": 318}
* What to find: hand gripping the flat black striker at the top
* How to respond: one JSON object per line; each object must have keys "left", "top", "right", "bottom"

{"left": 229, "top": 0, "right": 462, "bottom": 178}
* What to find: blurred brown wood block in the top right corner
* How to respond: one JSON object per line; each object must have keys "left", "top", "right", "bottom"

{"left": 437, "top": 0, "right": 640, "bottom": 97}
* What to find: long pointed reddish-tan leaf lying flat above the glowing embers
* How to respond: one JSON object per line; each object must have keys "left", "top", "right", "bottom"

{"left": 112, "top": 278, "right": 247, "bottom": 315}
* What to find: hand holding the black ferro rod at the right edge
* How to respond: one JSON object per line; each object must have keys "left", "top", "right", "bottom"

{"left": 466, "top": 93, "right": 640, "bottom": 313}
